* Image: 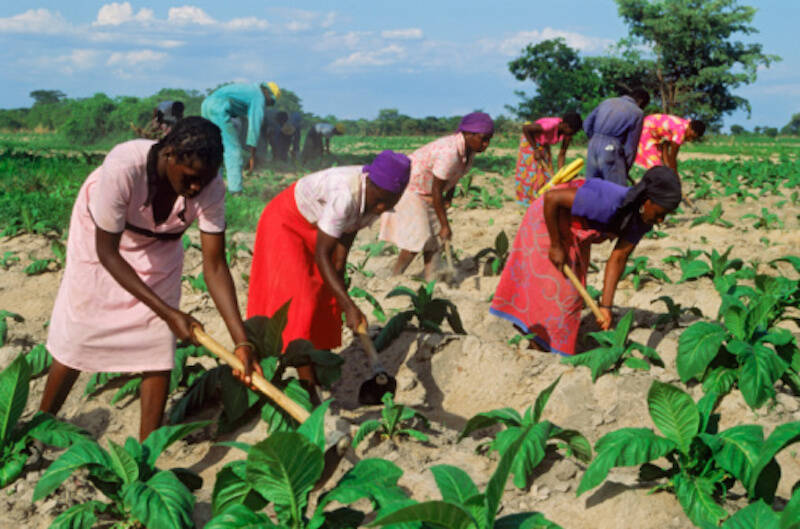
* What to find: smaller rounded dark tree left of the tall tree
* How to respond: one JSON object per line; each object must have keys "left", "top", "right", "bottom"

{"left": 507, "top": 38, "right": 603, "bottom": 120}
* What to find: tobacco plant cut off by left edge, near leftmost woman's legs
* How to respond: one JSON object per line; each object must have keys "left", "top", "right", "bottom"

{"left": 0, "top": 355, "right": 85, "bottom": 488}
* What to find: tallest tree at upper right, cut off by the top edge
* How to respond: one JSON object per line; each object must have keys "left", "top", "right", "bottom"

{"left": 617, "top": 0, "right": 780, "bottom": 125}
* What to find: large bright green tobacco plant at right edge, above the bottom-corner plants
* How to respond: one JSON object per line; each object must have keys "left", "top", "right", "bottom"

{"left": 677, "top": 276, "right": 800, "bottom": 409}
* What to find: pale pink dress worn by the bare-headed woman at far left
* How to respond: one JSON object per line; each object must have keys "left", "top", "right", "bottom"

{"left": 47, "top": 140, "right": 225, "bottom": 372}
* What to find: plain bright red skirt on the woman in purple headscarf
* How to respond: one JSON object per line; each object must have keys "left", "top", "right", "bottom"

{"left": 247, "top": 184, "right": 342, "bottom": 349}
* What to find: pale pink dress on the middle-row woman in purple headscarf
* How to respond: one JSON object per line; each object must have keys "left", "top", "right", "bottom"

{"left": 379, "top": 132, "right": 473, "bottom": 252}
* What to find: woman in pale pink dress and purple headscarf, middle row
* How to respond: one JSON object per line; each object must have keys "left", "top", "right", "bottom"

{"left": 379, "top": 112, "right": 494, "bottom": 281}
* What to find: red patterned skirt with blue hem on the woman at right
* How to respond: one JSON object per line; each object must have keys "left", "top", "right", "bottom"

{"left": 489, "top": 180, "right": 607, "bottom": 355}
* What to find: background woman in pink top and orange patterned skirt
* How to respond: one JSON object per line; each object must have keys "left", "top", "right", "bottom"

{"left": 517, "top": 112, "right": 583, "bottom": 206}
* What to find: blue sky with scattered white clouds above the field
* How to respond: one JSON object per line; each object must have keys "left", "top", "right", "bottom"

{"left": 0, "top": 0, "right": 800, "bottom": 129}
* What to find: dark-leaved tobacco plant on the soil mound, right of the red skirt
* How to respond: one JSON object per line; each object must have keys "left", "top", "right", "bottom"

{"left": 375, "top": 281, "right": 466, "bottom": 351}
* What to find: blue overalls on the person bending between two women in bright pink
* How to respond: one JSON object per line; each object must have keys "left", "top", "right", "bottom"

{"left": 583, "top": 96, "right": 644, "bottom": 167}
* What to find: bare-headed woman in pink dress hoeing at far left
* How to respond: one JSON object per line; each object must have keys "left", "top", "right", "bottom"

{"left": 40, "top": 117, "right": 261, "bottom": 440}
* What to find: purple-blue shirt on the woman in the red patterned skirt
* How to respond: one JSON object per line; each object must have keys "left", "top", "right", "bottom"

{"left": 571, "top": 178, "right": 653, "bottom": 244}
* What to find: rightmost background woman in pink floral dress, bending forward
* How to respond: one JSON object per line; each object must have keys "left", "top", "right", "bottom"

{"left": 636, "top": 114, "right": 706, "bottom": 171}
